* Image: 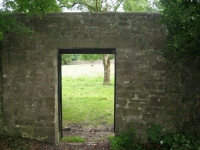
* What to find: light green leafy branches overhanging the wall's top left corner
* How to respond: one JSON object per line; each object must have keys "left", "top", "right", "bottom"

{"left": 0, "top": 0, "right": 61, "bottom": 42}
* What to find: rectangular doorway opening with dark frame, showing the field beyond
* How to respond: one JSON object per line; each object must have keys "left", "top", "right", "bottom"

{"left": 58, "top": 48, "right": 116, "bottom": 142}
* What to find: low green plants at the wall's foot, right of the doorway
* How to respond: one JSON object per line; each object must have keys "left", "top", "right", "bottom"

{"left": 109, "top": 125, "right": 200, "bottom": 150}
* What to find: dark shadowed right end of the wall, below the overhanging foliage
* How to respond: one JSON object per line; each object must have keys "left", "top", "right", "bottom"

{"left": 164, "top": 64, "right": 200, "bottom": 134}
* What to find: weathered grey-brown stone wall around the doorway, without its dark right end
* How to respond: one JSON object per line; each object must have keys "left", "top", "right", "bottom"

{"left": 2, "top": 13, "right": 198, "bottom": 143}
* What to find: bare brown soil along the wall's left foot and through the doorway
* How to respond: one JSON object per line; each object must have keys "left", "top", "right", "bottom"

{"left": 0, "top": 124, "right": 114, "bottom": 150}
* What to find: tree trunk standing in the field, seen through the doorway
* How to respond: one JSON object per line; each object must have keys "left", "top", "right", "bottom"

{"left": 103, "top": 54, "right": 110, "bottom": 84}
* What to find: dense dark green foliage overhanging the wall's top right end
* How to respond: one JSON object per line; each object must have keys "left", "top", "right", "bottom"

{"left": 160, "top": 0, "right": 200, "bottom": 69}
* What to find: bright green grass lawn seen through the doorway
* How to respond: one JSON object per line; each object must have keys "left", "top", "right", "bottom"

{"left": 62, "top": 77, "right": 114, "bottom": 126}
